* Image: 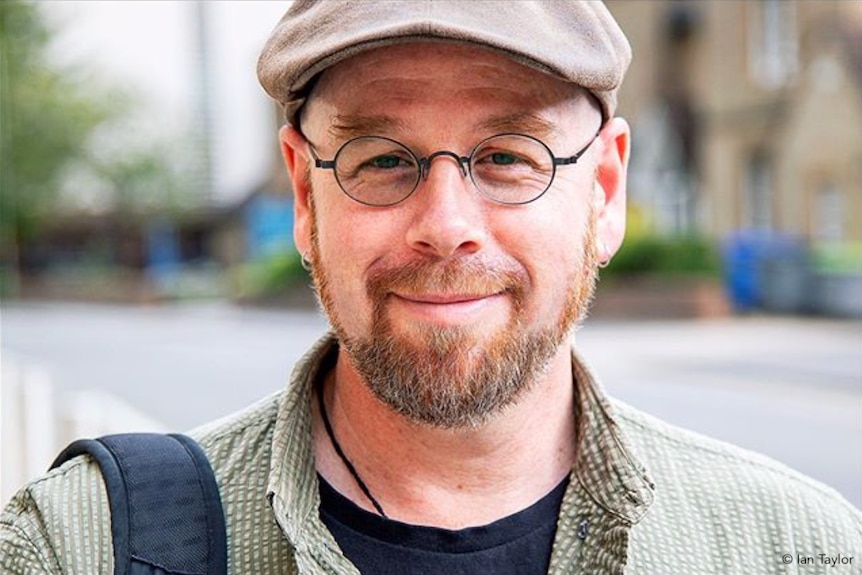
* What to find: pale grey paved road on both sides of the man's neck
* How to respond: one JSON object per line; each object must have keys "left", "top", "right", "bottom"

{"left": 0, "top": 304, "right": 862, "bottom": 506}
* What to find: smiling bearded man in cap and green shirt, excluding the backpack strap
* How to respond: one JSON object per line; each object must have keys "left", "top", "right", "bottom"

{"left": 0, "top": 0, "right": 862, "bottom": 574}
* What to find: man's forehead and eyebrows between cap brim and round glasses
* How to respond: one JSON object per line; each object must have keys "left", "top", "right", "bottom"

{"left": 303, "top": 42, "right": 589, "bottom": 142}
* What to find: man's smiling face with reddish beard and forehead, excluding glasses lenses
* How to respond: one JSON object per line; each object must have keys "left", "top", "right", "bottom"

{"left": 284, "top": 44, "right": 628, "bottom": 427}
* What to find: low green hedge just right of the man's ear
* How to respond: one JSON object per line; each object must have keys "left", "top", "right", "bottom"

{"left": 602, "top": 235, "right": 720, "bottom": 278}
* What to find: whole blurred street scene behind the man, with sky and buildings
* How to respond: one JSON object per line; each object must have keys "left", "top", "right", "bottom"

{"left": 0, "top": 0, "right": 862, "bottom": 506}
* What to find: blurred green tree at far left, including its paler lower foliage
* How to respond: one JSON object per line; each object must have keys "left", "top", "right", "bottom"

{"left": 0, "top": 0, "right": 195, "bottom": 293}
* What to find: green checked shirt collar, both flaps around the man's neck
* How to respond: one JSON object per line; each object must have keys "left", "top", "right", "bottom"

{"left": 267, "top": 333, "right": 654, "bottom": 555}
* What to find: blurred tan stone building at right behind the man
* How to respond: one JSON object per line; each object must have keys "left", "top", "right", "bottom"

{"left": 607, "top": 0, "right": 862, "bottom": 241}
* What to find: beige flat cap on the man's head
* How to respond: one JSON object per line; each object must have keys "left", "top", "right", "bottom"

{"left": 257, "top": 0, "right": 631, "bottom": 124}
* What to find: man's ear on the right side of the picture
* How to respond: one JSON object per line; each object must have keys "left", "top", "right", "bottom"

{"left": 594, "top": 118, "right": 631, "bottom": 258}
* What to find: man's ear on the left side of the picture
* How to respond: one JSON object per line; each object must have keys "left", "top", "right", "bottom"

{"left": 278, "top": 124, "right": 314, "bottom": 260}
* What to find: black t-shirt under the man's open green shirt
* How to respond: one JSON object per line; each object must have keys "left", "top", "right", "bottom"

{"left": 320, "top": 477, "right": 568, "bottom": 575}
